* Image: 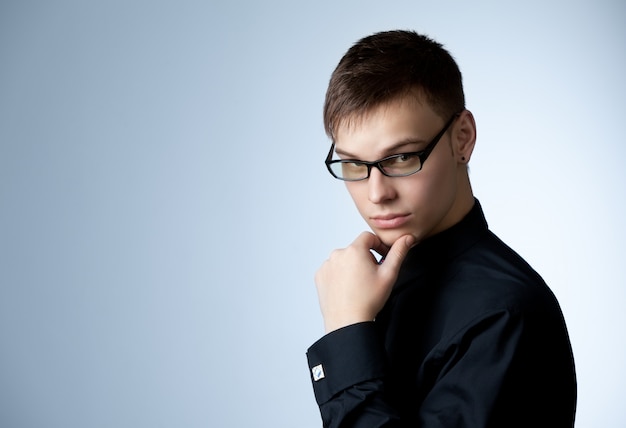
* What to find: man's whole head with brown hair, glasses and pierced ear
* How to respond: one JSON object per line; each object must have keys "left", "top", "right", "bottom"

{"left": 324, "top": 31, "right": 476, "bottom": 245}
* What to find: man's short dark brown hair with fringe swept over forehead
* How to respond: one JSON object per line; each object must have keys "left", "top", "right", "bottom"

{"left": 324, "top": 30, "right": 465, "bottom": 138}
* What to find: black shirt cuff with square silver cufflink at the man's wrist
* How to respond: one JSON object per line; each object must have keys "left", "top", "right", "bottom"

{"left": 307, "top": 322, "right": 385, "bottom": 405}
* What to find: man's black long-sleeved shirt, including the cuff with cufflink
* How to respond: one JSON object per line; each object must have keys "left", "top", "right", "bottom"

{"left": 307, "top": 201, "right": 576, "bottom": 428}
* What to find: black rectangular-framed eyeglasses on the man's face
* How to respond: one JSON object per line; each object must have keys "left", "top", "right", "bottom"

{"left": 325, "top": 113, "right": 460, "bottom": 181}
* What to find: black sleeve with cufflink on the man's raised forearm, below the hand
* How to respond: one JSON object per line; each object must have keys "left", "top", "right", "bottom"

{"left": 307, "top": 322, "right": 400, "bottom": 428}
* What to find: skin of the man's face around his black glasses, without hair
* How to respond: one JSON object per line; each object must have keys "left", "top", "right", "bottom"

{"left": 335, "top": 95, "right": 473, "bottom": 245}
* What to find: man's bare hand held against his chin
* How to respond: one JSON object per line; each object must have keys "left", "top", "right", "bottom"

{"left": 315, "top": 232, "right": 415, "bottom": 333}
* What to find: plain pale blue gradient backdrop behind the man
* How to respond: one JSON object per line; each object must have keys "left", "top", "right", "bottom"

{"left": 0, "top": 0, "right": 626, "bottom": 428}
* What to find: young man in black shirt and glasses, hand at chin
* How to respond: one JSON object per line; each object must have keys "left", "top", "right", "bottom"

{"left": 307, "top": 31, "right": 576, "bottom": 428}
